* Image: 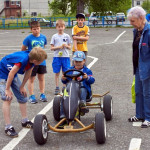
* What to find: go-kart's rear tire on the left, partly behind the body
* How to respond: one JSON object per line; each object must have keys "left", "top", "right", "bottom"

{"left": 53, "top": 96, "right": 63, "bottom": 121}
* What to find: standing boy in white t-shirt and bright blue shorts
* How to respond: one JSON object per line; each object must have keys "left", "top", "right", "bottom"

{"left": 50, "top": 19, "right": 71, "bottom": 95}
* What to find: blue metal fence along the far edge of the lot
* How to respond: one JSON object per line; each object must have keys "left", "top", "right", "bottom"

{"left": 0, "top": 16, "right": 129, "bottom": 29}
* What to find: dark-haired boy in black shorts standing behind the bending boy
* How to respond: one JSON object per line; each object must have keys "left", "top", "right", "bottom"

{"left": 22, "top": 21, "right": 47, "bottom": 104}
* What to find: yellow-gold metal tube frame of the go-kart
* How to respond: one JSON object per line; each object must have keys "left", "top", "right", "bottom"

{"left": 48, "top": 91, "right": 109, "bottom": 133}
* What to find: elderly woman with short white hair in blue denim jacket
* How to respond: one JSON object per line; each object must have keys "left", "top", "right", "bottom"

{"left": 127, "top": 6, "right": 150, "bottom": 128}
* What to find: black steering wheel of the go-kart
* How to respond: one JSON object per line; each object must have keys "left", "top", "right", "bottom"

{"left": 64, "top": 69, "right": 84, "bottom": 82}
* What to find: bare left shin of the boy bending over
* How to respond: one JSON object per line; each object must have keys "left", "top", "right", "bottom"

{"left": 2, "top": 101, "right": 11, "bottom": 125}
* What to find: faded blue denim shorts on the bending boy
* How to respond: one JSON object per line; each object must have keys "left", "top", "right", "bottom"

{"left": 0, "top": 77, "right": 28, "bottom": 103}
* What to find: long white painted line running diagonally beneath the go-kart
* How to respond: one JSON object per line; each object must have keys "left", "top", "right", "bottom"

{"left": 2, "top": 56, "right": 98, "bottom": 150}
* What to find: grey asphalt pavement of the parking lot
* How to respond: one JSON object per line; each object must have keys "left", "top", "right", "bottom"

{"left": 0, "top": 28, "right": 150, "bottom": 150}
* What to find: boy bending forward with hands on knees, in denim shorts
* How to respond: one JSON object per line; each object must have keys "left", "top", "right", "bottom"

{"left": 0, "top": 48, "right": 47, "bottom": 137}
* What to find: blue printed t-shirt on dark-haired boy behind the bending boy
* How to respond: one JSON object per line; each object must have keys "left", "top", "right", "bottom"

{"left": 23, "top": 34, "right": 47, "bottom": 66}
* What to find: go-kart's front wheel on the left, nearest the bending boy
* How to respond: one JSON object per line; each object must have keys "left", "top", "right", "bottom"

{"left": 33, "top": 114, "right": 48, "bottom": 145}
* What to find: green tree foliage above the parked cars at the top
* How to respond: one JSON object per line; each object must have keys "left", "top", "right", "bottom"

{"left": 49, "top": 0, "right": 132, "bottom": 16}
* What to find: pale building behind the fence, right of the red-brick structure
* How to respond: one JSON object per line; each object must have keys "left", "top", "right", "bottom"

{"left": 21, "top": 0, "right": 52, "bottom": 16}
